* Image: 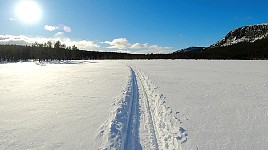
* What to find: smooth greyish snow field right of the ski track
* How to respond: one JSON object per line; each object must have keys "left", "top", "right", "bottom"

{"left": 125, "top": 60, "right": 268, "bottom": 150}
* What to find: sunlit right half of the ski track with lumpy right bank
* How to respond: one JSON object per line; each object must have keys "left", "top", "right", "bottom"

{"left": 136, "top": 69, "right": 188, "bottom": 150}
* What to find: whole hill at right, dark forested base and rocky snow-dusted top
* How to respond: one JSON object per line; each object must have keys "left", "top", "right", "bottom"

{"left": 173, "top": 24, "right": 268, "bottom": 59}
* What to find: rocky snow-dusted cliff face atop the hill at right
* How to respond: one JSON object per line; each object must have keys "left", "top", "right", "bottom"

{"left": 211, "top": 23, "right": 268, "bottom": 47}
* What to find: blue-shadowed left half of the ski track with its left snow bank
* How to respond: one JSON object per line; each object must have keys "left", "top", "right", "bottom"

{"left": 98, "top": 69, "right": 141, "bottom": 150}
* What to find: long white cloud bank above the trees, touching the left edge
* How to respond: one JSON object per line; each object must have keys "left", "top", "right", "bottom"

{"left": 0, "top": 33, "right": 100, "bottom": 50}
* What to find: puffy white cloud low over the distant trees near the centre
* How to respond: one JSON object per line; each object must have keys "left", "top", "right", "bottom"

{"left": 104, "top": 38, "right": 174, "bottom": 53}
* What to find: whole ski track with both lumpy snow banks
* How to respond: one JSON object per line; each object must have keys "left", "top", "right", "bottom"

{"left": 97, "top": 66, "right": 188, "bottom": 150}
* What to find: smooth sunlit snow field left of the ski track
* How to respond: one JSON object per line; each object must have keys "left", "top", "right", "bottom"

{"left": 0, "top": 61, "right": 129, "bottom": 150}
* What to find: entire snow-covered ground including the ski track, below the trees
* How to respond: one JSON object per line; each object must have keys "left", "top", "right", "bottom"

{"left": 0, "top": 60, "right": 268, "bottom": 149}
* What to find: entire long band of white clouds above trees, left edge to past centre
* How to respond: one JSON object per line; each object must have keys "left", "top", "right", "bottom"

{"left": 0, "top": 35, "right": 175, "bottom": 54}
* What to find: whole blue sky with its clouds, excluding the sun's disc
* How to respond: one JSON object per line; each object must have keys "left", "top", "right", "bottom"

{"left": 0, "top": 0, "right": 268, "bottom": 53}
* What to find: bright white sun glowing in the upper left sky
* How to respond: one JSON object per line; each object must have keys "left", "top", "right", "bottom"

{"left": 16, "top": 0, "right": 41, "bottom": 24}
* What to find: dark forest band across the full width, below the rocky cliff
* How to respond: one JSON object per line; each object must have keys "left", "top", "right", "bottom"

{"left": 0, "top": 38, "right": 268, "bottom": 62}
